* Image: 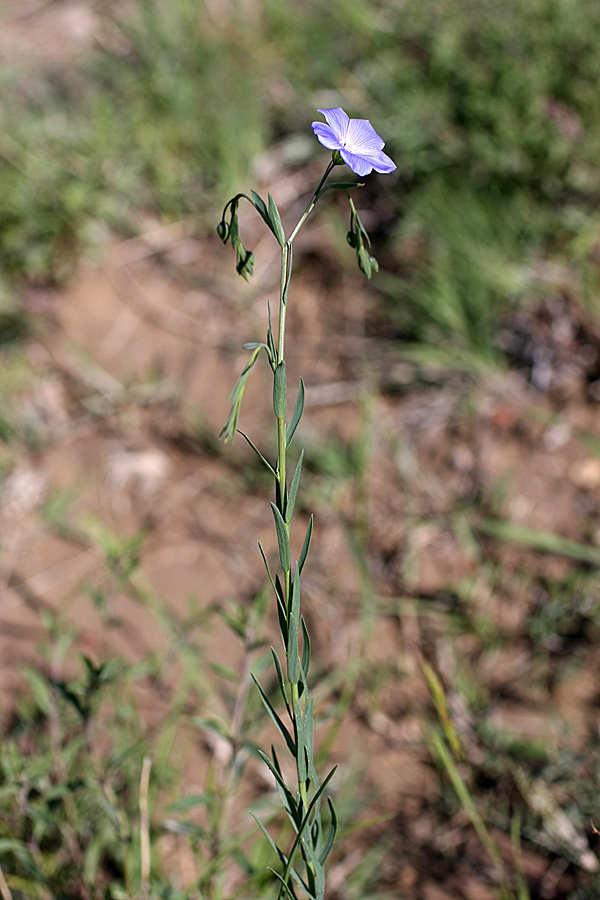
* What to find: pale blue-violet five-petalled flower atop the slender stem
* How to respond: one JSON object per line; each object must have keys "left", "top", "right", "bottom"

{"left": 312, "top": 106, "right": 396, "bottom": 177}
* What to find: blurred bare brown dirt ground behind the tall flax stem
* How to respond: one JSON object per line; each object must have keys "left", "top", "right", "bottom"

{"left": 0, "top": 214, "right": 600, "bottom": 900}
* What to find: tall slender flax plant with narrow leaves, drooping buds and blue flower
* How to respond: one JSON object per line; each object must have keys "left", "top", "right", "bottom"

{"left": 217, "top": 108, "right": 396, "bottom": 900}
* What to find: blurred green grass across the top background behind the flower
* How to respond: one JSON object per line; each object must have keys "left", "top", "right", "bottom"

{"left": 7, "top": 0, "right": 600, "bottom": 362}
